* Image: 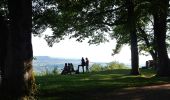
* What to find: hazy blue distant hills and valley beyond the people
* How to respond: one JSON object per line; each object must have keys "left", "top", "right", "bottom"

{"left": 33, "top": 56, "right": 93, "bottom": 73}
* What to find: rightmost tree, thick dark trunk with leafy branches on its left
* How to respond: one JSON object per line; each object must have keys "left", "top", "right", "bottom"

{"left": 111, "top": 0, "right": 170, "bottom": 76}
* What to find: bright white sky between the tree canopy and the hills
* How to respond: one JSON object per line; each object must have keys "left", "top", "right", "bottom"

{"left": 32, "top": 30, "right": 151, "bottom": 65}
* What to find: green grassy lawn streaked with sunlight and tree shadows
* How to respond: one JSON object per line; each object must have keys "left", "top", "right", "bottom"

{"left": 36, "top": 69, "right": 170, "bottom": 100}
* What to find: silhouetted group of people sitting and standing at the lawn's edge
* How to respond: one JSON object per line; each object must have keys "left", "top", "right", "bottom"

{"left": 61, "top": 57, "right": 89, "bottom": 75}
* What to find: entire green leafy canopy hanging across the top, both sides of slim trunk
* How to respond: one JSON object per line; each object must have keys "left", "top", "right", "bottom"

{"left": 33, "top": 0, "right": 168, "bottom": 62}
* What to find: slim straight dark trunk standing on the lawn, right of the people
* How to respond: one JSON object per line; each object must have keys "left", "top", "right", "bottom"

{"left": 127, "top": 0, "right": 140, "bottom": 75}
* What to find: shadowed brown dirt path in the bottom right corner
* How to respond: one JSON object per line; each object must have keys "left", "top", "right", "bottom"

{"left": 96, "top": 84, "right": 170, "bottom": 100}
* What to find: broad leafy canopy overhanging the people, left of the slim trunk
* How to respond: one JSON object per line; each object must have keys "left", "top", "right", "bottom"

{"left": 33, "top": 0, "right": 127, "bottom": 46}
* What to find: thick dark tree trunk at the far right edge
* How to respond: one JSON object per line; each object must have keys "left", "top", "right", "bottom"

{"left": 153, "top": 0, "right": 170, "bottom": 76}
